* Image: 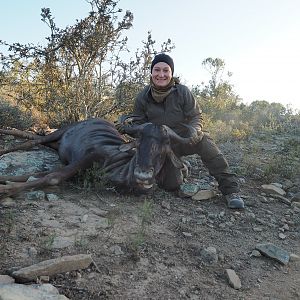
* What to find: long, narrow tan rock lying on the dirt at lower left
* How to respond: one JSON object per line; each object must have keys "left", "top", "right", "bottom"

{"left": 12, "top": 254, "right": 93, "bottom": 282}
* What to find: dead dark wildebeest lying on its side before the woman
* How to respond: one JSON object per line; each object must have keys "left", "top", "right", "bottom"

{"left": 0, "top": 116, "right": 199, "bottom": 195}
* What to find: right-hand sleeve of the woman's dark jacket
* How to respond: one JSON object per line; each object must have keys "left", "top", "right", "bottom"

{"left": 183, "top": 88, "right": 203, "bottom": 133}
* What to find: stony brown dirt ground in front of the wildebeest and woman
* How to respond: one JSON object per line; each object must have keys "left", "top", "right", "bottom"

{"left": 0, "top": 137, "right": 300, "bottom": 300}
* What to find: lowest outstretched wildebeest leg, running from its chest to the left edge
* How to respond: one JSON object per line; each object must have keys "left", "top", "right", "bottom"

{"left": 0, "top": 154, "right": 99, "bottom": 196}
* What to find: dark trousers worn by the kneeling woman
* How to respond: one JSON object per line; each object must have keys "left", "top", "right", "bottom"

{"left": 158, "top": 134, "right": 240, "bottom": 195}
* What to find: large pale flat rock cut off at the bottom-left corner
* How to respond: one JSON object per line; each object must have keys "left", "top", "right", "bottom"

{"left": 0, "top": 283, "right": 69, "bottom": 300}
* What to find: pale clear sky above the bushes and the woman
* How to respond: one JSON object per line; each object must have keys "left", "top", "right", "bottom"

{"left": 0, "top": 0, "right": 300, "bottom": 110}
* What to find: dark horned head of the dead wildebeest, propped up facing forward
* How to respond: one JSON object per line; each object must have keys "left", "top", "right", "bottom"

{"left": 120, "top": 123, "right": 196, "bottom": 189}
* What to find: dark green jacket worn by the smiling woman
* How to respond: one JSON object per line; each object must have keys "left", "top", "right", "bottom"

{"left": 134, "top": 84, "right": 202, "bottom": 136}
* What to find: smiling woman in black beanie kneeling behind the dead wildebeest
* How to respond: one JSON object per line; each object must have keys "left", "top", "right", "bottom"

{"left": 134, "top": 53, "right": 244, "bottom": 208}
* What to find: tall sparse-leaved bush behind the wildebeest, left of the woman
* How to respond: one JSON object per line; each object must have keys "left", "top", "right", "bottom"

{"left": 1, "top": 0, "right": 173, "bottom": 124}
